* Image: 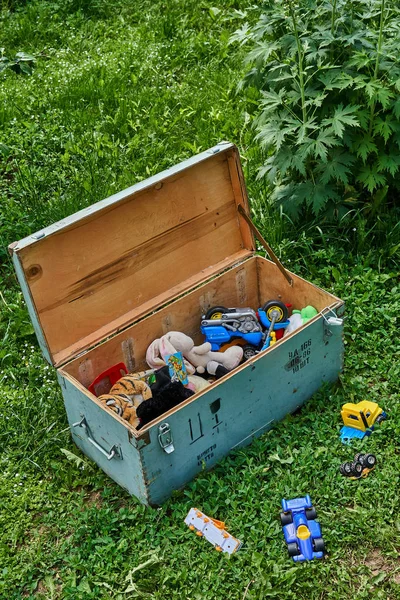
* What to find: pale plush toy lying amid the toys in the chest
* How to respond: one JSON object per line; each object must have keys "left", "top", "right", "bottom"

{"left": 146, "top": 331, "right": 243, "bottom": 374}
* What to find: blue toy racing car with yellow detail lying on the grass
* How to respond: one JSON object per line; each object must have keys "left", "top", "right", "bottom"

{"left": 281, "top": 494, "right": 325, "bottom": 562}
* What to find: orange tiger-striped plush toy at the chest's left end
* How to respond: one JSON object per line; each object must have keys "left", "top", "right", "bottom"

{"left": 98, "top": 373, "right": 152, "bottom": 429}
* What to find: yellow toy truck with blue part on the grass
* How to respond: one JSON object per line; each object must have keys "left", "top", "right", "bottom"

{"left": 340, "top": 400, "right": 387, "bottom": 444}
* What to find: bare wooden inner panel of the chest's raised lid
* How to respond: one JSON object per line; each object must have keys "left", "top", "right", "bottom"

{"left": 16, "top": 147, "right": 252, "bottom": 364}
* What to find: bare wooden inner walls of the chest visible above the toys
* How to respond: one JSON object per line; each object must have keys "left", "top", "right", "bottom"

{"left": 62, "top": 256, "right": 341, "bottom": 434}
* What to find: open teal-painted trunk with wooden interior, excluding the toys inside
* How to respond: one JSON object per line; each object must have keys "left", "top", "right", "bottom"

{"left": 10, "top": 143, "right": 344, "bottom": 505}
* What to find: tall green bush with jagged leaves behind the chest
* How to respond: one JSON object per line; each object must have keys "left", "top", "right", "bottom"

{"left": 232, "top": 0, "right": 400, "bottom": 217}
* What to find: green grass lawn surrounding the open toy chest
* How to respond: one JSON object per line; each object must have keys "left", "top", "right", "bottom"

{"left": 0, "top": 0, "right": 400, "bottom": 600}
